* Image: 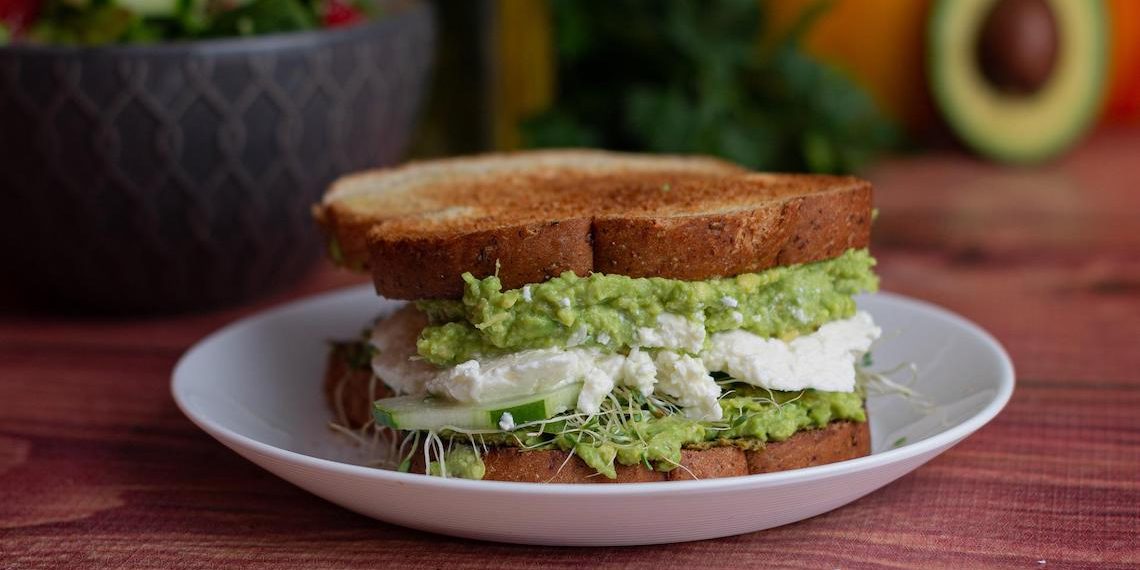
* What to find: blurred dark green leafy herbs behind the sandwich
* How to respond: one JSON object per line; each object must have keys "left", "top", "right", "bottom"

{"left": 522, "top": 0, "right": 901, "bottom": 172}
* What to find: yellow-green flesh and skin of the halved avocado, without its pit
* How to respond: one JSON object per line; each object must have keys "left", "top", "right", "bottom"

{"left": 927, "top": 0, "right": 1108, "bottom": 162}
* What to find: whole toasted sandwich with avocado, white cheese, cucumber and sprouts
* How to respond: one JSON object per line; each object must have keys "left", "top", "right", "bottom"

{"left": 314, "top": 150, "right": 880, "bottom": 483}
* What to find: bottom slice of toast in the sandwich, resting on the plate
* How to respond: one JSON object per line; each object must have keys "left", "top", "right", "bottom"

{"left": 324, "top": 350, "right": 871, "bottom": 483}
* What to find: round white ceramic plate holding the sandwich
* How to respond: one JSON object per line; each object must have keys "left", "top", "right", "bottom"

{"left": 172, "top": 286, "right": 1013, "bottom": 545}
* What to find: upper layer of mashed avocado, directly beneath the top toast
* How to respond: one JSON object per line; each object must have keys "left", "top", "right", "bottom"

{"left": 416, "top": 250, "right": 878, "bottom": 366}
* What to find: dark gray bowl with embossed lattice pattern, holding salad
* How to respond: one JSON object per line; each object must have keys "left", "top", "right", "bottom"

{"left": 0, "top": 2, "right": 434, "bottom": 312}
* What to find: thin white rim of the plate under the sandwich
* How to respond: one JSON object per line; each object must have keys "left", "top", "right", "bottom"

{"left": 170, "top": 284, "right": 1017, "bottom": 497}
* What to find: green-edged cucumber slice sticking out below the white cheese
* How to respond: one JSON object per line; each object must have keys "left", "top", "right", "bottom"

{"left": 372, "top": 383, "right": 581, "bottom": 430}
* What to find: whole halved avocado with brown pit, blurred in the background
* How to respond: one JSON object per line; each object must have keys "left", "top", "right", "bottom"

{"left": 927, "top": 0, "right": 1108, "bottom": 162}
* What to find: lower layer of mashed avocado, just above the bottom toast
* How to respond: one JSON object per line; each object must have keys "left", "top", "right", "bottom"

{"left": 432, "top": 386, "right": 866, "bottom": 479}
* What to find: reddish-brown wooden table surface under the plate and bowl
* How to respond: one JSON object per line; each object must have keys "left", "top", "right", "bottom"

{"left": 0, "top": 131, "right": 1140, "bottom": 570}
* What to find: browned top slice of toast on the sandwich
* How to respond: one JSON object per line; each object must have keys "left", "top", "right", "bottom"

{"left": 314, "top": 150, "right": 871, "bottom": 299}
